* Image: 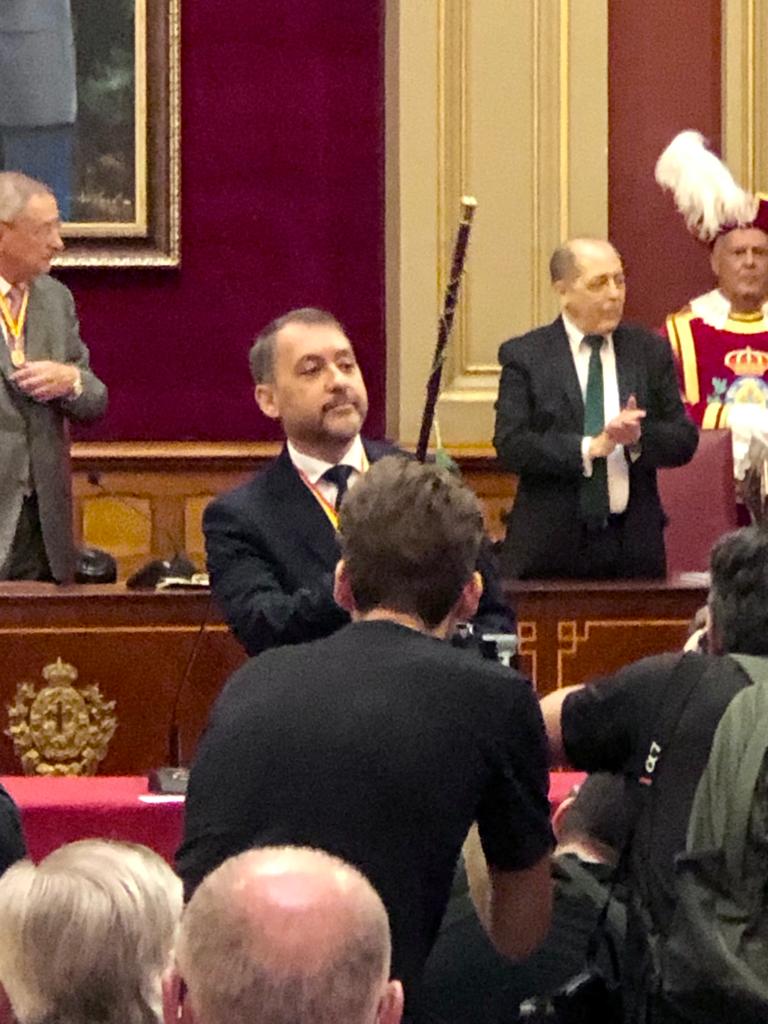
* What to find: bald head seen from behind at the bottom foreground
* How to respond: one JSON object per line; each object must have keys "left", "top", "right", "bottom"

{"left": 171, "top": 847, "right": 401, "bottom": 1024}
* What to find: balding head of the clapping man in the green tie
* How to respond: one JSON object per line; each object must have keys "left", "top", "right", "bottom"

{"left": 550, "top": 238, "right": 626, "bottom": 335}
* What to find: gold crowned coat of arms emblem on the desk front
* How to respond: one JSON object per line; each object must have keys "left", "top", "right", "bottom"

{"left": 5, "top": 657, "right": 118, "bottom": 775}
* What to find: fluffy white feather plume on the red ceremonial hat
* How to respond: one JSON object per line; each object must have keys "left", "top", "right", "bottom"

{"left": 655, "top": 131, "right": 758, "bottom": 242}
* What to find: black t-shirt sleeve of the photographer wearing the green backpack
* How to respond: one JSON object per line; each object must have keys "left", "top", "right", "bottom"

{"left": 560, "top": 654, "right": 680, "bottom": 772}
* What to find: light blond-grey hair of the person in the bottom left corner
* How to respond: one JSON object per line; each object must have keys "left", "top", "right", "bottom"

{"left": 0, "top": 840, "right": 182, "bottom": 1024}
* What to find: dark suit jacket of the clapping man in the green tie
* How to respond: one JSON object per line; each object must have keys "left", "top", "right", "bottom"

{"left": 494, "top": 316, "right": 698, "bottom": 579}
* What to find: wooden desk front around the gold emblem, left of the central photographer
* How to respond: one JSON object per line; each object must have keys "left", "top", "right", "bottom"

{"left": 0, "top": 583, "right": 245, "bottom": 775}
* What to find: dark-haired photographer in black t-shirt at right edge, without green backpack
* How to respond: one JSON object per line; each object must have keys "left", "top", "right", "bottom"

{"left": 542, "top": 526, "right": 768, "bottom": 1024}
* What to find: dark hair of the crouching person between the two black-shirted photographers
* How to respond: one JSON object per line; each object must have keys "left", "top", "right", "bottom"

{"left": 558, "top": 772, "right": 629, "bottom": 862}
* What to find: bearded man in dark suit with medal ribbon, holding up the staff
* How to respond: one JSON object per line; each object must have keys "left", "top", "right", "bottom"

{"left": 203, "top": 308, "right": 514, "bottom": 654}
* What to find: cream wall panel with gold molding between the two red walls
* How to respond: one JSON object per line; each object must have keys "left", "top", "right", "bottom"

{"left": 386, "top": 0, "right": 608, "bottom": 446}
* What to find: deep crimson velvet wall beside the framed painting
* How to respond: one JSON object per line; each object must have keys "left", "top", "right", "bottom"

{"left": 67, "top": 0, "right": 385, "bottom": 440}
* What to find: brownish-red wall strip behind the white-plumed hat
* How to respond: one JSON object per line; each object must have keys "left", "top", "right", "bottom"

{"left": 608, "top": 0, "right": 721, "bottom": 327}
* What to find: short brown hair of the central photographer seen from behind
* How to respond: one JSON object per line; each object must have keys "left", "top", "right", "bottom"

{"left": 339, "top": 456, "right": 483, "bottom": 628}
